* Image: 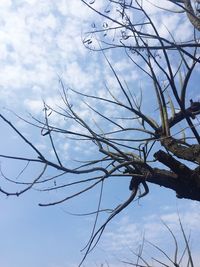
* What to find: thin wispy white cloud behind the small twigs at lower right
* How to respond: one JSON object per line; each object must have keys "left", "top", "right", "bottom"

{"left": 103, "top": 203, "right": 200, "bottom": 264}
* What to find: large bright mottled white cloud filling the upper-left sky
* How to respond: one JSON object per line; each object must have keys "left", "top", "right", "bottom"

{"left": 0, "top": 1, "right": 103, "bottom": 108}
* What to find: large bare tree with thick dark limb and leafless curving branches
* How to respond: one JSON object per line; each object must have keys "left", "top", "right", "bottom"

{"left": 0, "top": 0, "right": 200, "bottom": 266}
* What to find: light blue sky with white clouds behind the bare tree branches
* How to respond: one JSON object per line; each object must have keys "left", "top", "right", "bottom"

{"left": 0, "top": 0, "right": 200, "bottom": 267}
